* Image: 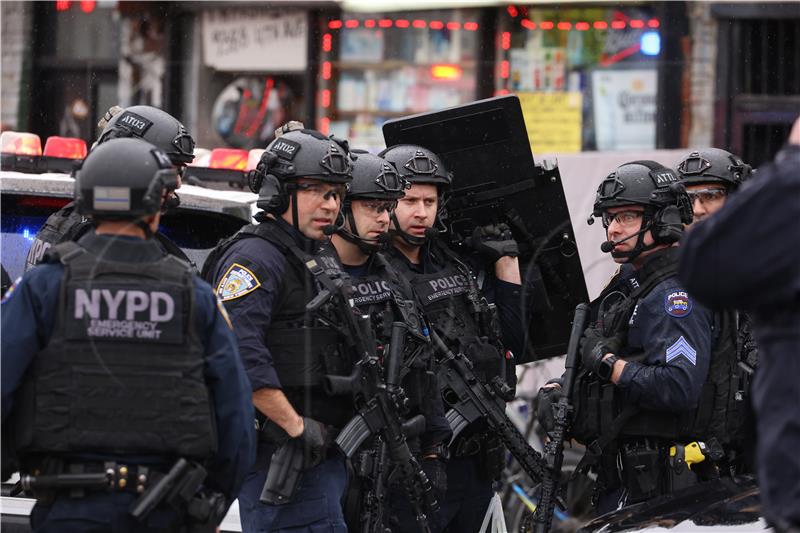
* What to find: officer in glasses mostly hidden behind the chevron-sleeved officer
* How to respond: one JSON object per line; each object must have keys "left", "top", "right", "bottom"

{"left": 677, "top": 148, "right": 758, "bottom": 473}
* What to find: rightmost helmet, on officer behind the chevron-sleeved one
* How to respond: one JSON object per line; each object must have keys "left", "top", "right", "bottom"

{"left": 677, "top": 148, "right": 751, "bottom": 190}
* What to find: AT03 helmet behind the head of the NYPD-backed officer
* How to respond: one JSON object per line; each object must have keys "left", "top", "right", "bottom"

{"left": 96, "top": 105, "right": 195, "bottom": 166}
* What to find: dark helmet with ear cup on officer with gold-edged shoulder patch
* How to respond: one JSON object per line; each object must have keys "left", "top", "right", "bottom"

{"left": 248, "top": 129, "right": 353, "bottom": 214}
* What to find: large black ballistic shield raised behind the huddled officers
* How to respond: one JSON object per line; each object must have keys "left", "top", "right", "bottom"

{"left": 383, "top": 95, "right": 588, "bottom": 363}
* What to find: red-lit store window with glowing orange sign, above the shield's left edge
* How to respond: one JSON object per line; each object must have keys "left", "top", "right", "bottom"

{"left": 317, "top": 9, "right": 479, "bottom": 151}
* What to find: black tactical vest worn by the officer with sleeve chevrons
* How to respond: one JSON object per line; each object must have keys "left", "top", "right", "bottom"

{"left": 572, "top": 249, "right": 736, "bottom": 444}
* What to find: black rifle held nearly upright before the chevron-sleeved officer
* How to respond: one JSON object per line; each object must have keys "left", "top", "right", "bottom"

{"left": 533, "top": 303, "right": 589, "bottom": 533}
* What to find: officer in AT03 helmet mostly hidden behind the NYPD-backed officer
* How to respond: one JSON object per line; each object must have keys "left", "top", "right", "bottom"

{"left": 25, "top": 105, "right": 195, "bottom": 271}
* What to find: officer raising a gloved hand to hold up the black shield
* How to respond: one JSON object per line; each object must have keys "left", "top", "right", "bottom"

{"left": 381, "top": 145, "right": 523, "bottom": 532}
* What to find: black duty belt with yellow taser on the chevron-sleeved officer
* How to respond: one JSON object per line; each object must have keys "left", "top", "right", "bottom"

{"left": 618, "top": 438, "right": 724, "bottom": 505}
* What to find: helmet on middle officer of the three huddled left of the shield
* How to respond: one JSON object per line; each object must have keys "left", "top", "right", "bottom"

{"left": 346, "top": 150, "right": 408, "bottom": 200}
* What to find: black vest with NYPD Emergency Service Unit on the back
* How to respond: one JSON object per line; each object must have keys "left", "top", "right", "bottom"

{"left": 14, "top": 242, "right": 217, "bottom": 459}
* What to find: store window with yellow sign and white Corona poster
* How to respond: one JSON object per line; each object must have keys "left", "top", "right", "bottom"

{"left": 495, "top": 5, "right": 664, "bottom": 153}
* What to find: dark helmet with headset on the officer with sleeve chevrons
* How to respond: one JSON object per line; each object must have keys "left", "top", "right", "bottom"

{"left": 589, "top": 161, "right": 692, "bottom": 258}
